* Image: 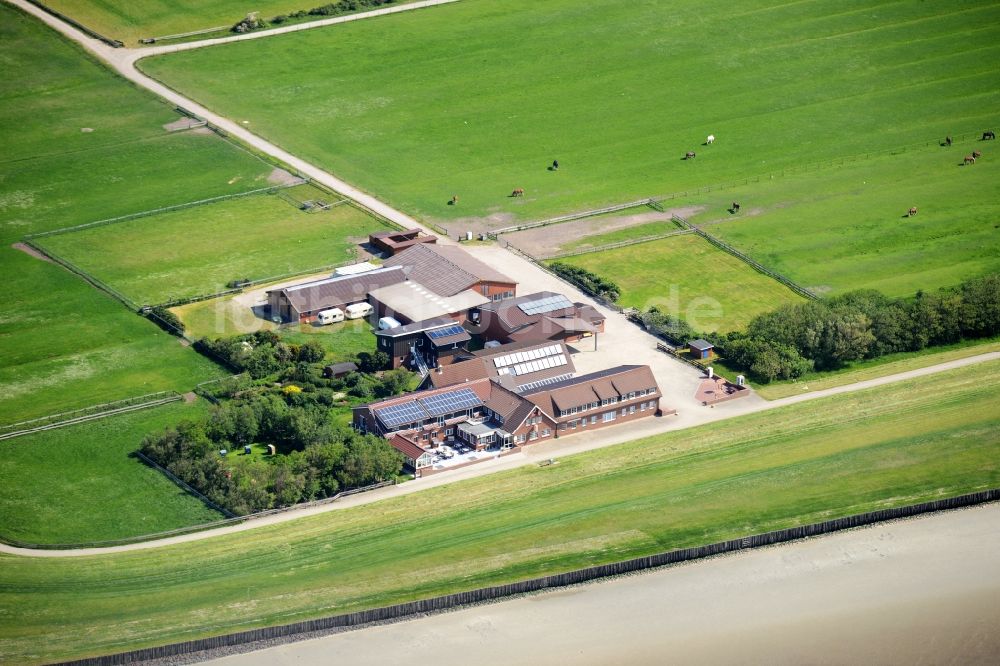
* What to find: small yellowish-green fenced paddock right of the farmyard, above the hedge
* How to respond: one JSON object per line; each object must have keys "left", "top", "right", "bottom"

{"left": 559, "top": 234, "right": 801, "bottom": 332}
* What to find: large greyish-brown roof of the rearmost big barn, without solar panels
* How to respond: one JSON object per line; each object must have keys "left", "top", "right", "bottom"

{"left": 385, "top": 244, "right": 516, "bottom": 296}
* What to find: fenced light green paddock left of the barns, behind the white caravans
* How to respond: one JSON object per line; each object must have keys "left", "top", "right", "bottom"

{"left": 40, "top": 185, "right": 385, "bottom": 305}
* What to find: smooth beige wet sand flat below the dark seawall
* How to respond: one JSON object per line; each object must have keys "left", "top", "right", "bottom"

{"left": 205, "top": 504, "right": 1000, "bottom": 666}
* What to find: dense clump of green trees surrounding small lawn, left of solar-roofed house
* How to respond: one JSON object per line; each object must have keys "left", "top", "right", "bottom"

{"left": 141, "top": 392, "right": 403, "bottom": 515}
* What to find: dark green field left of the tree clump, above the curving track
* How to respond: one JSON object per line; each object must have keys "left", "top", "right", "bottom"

{"left": 0, "top": 401, "right": 223, "bottom": 544}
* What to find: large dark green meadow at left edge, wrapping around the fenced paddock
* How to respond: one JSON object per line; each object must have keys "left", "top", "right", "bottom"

{"left": 0, "top": 5, "right": 272, "bottom": 423}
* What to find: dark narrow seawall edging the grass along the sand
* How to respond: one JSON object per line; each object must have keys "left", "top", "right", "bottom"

{"left": 54, "top": 489, "right": 1000, "bottom": 666}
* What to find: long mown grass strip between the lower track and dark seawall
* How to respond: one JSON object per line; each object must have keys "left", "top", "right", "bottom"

{"left": 0, "top": 362, "right": 1000, "bottom": 663}
